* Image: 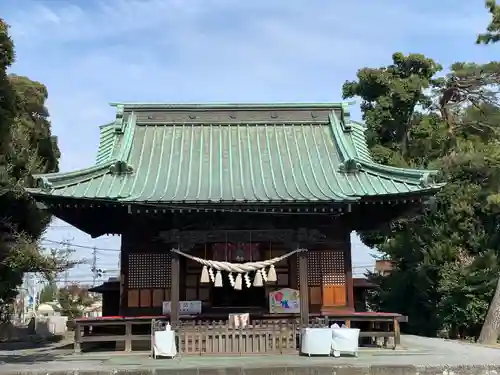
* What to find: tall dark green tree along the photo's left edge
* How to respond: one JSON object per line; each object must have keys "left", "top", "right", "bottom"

{"left": 0, "top": 19, "right": 64, "bottom": 317}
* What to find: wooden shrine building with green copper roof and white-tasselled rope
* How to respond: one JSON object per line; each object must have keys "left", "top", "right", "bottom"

{"left": 30, "top": 103, "right": 440, "bottom": 324}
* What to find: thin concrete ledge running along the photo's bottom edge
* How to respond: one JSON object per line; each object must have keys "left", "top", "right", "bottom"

{"left": 0, "top": 363, "right": 500, "bottom": 375}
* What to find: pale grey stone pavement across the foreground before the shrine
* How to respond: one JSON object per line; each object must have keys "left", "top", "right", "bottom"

{"left": 0, "top": 336, "right": 500, "bottom": 375}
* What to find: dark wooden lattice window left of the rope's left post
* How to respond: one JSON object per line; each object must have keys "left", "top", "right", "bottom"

{"left": 127, "top": 253, "right": 171, "bottom": 289}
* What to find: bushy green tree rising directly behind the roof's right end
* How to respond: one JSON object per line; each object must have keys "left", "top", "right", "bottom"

{"left": 342, "top": 53, "right": 441, "bottom": 166}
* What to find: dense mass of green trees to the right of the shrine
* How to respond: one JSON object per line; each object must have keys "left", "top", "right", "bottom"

{"left": 344, "top": 54, "right": 500, "bottom": 337}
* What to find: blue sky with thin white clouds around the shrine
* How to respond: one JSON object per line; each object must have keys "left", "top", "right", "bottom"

{"left": 0, "top": 0, "right": 498, "bottom": 281}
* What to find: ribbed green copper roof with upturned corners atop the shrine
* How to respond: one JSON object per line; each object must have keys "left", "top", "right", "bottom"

{"left": 32, "top": 104, "right": 439, "bottom": 202}
